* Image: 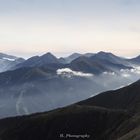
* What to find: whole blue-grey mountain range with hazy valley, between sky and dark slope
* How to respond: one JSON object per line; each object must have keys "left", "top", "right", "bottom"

{"left": 0, "top": 52, "right": 140, "bottom": 118}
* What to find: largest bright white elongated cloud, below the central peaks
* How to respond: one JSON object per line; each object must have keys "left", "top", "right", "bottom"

{"left": 57, "top": 68, "right": 93, "bottom": 78}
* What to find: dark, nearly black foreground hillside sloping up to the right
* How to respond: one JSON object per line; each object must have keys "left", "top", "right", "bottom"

{"left": 0, "top": 81, "right": 140, "bottom": 140}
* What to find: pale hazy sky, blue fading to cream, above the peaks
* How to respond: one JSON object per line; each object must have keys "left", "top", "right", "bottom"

{"left": 0, "top": 0, "right": 140, "bottom": 57}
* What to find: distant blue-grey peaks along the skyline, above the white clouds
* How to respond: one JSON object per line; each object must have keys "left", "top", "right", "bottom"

{"left": 0, "top": 51, "right": 140, "bottom": 74}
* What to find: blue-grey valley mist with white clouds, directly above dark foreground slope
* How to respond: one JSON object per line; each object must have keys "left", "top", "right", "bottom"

{"left": 0, "top": 67, "right": 140, "bottom": 118}
